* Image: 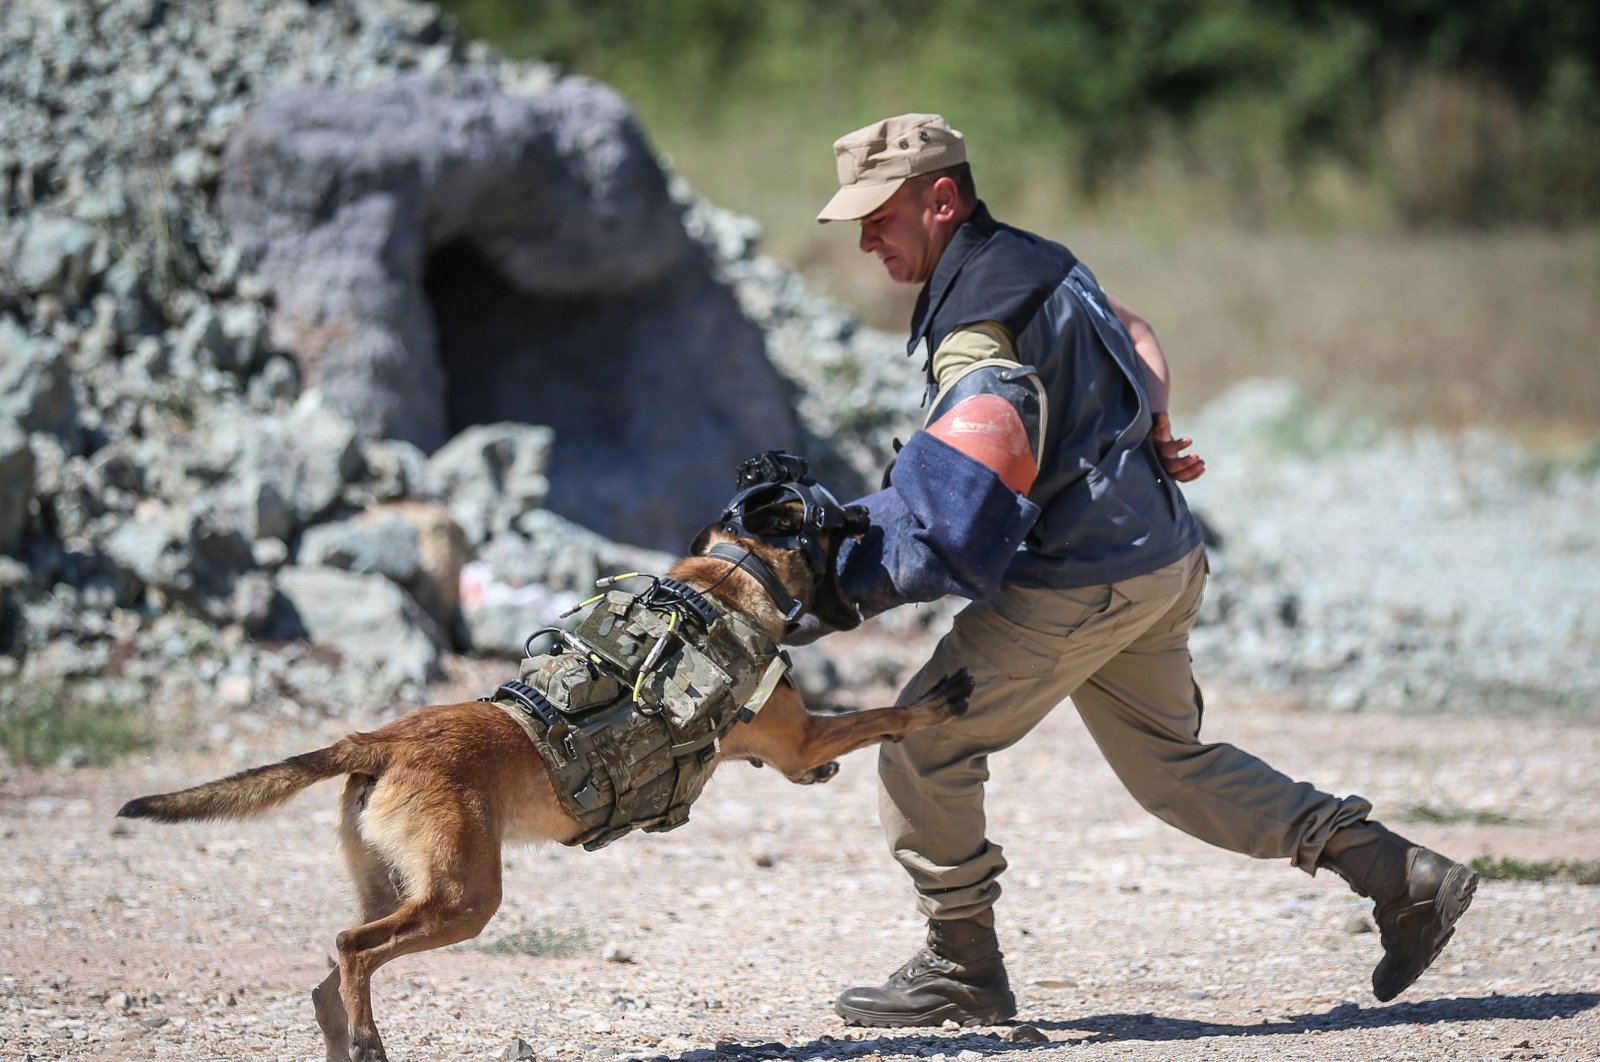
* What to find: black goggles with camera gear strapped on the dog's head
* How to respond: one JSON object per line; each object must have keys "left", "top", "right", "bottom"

{"left": 722, "top": 449, "right": 872, "bottom": 571}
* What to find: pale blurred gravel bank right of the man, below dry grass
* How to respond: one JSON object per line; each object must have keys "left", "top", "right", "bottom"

{"left": 1178, "top": 381, "right": 1600, "bottom": 720}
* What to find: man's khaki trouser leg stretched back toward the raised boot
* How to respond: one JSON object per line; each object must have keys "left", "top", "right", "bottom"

{"left": 1072, "top": 555, "right": 1371, "bottom": 873}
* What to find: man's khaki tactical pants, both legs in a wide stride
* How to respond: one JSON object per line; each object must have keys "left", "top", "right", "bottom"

{"left": 878, "top": 547, "right": 1371, "bottom": 918}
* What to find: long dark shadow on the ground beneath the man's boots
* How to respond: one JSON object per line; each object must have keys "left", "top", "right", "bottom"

{"left": 677, "top": 992, "right": 1600, "bottom": 1062}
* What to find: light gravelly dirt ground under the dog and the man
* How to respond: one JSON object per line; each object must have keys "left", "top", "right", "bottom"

{"left": 0, "top": 691, "right": 1600, "bottom": 1062}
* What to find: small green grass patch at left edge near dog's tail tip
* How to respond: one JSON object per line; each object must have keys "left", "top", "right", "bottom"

{"left": 0, "top": 685, "right": 155, "bottom": 768}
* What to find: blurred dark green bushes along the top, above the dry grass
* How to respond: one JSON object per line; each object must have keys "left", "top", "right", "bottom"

{"left": 440, "top": 0, "right": 1600, "bottom": 227}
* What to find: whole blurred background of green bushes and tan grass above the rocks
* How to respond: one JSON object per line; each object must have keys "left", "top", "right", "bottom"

{"left": 428, "top": 0, "right": 1600, "bottom": 447}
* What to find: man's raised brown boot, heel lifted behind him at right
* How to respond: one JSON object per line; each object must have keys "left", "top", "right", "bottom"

{"left": 1317, "top": 822, "right": 1478, "bottom": 1003}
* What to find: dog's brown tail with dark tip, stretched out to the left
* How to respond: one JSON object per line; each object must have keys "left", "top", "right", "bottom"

{"left": 117, "top": 736, "right": 387, "bottom": 822}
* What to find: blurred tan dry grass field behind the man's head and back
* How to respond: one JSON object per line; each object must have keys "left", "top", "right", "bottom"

{"left": 770, "top": 215, "right": 1600, "bottom": 453}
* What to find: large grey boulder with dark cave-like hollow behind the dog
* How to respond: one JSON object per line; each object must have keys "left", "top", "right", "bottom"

{"left": 221, "top": 70, "right": 800, "bottom": 549}
